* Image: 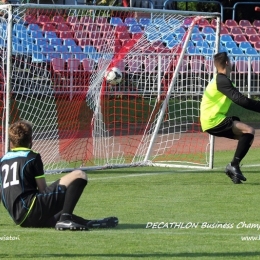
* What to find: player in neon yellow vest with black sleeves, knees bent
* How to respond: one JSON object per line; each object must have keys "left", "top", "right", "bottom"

{"left": 200, "top": 52, "right": 260, "bottom": 184}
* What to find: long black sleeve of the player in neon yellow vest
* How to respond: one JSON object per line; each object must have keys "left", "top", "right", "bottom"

{"left": 216, "top": 73, "right": 260, "bottom": 113}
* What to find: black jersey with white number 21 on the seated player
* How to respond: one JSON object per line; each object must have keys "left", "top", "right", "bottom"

{"left": 0, "top": 148, "right": 44, "bottom": 224}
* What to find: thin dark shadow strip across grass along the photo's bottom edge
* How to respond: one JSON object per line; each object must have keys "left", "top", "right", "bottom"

{"left": 0, "top": 252, "right": 260, "bottom": 259}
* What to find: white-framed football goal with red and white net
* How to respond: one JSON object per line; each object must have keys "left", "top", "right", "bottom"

{"left": 0, "top": 4, "right": 220, "bottom": 173}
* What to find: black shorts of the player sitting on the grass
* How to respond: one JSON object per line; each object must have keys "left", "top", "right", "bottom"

{"left": 21, "top": 180, "right": 67, "bottom": 227}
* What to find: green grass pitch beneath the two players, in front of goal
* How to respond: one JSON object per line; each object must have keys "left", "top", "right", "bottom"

{"left": 0, "top": 149, "right": 260, "bottom": 259}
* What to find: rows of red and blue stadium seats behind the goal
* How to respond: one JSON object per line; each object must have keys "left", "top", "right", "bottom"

{"left": 8, "top": 11, "right": 260, "bottom": 94}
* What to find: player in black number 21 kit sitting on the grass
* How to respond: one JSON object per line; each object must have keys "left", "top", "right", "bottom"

{"left": 0, "top": 120, "right": 118, "bottom": 230}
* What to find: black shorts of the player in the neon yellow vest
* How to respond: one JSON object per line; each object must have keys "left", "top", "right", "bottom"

{"left": 206, "top": 116, "right": 240, "bottom": 139}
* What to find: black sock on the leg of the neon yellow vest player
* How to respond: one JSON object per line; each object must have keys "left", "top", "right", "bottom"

{"left": 231, "top": 134, "right": 254, "bottom": 166}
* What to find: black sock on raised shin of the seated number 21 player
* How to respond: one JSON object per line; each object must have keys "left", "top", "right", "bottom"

{"left": 60, "top": 178, "right": 88, "bottom": 220}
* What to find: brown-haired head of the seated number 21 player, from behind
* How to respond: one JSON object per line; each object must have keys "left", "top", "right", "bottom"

{"left": 9, "top": 120, "right": 32, "bottom": 148}
